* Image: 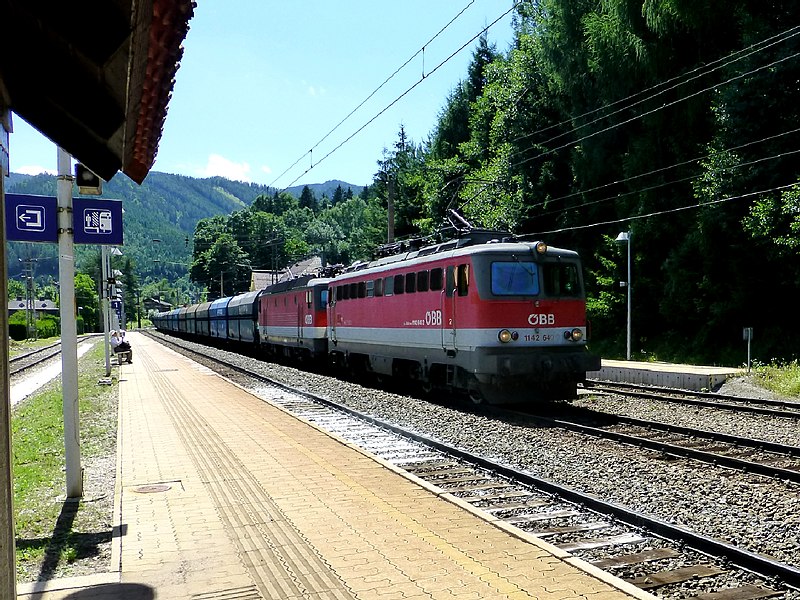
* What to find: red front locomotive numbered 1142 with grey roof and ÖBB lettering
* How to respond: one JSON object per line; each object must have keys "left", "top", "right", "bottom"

{"left": 328, "top": 230, "right": 600, "bottom": 403}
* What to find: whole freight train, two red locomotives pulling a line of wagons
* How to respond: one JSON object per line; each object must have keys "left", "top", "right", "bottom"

{"left": 153, "top": 230, "right": 600, "bottom": 404}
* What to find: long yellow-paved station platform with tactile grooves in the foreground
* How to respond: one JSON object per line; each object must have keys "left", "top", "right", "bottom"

{"left": 18, "top": 333, "right": 654, "bottom": 600}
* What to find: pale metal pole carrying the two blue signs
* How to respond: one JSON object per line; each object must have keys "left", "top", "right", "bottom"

{"left": 56, "top": 148, "right": 83, "bottom": 498}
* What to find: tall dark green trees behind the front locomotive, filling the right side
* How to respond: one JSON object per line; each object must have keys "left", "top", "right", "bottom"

{"left": 358, "top": 0, "right": 800, "bottom": 363}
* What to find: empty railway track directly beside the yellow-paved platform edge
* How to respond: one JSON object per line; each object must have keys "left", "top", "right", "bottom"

{"left": 152, "top": 338, "right": 800, "bottom": 600}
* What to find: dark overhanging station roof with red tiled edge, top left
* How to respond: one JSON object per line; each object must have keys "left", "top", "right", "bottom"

{"left": 0, "top": 0, "right": 195, "bottom": 183}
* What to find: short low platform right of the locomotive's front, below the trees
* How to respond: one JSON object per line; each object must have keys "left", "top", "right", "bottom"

{"left": 586, "top": 359, "right": 745, "bottom": 392}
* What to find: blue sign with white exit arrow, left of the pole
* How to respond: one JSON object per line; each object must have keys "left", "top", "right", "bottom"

{"left": 6, "top": 194, "right": 58, "bottom": 243}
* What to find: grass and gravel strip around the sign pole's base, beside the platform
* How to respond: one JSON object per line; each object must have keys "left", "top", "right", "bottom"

{"left": 11, "top": 343, "right": 118, "bottom": 581}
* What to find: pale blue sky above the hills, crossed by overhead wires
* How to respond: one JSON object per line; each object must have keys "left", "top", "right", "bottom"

{"left": 10, "top": 0, "right": 513, "bottom": 188}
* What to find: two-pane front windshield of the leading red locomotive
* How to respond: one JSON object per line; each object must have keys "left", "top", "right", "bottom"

{"left": 491, "top": 261, "right": 581, "bottom": 298}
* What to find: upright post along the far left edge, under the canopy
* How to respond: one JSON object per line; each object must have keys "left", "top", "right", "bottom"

{"left": 0, "top": 108, "right": 17, "bottom": 598}
